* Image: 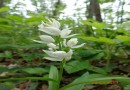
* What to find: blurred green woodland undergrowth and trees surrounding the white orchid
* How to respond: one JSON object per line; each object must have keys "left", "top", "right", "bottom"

{"left": 0, "top": 0, "right": 130, "bottom": 90}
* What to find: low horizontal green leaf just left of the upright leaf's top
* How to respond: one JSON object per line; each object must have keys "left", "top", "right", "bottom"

{"left": 22, "top": 67, "right": 48, "bottom": 74}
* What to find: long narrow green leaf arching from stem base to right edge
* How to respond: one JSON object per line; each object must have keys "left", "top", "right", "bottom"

{"left": 60, "top": 74, "right": 130, "bottom": 90}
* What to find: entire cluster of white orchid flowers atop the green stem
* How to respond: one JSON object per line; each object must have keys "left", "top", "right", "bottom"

{"left": 33, "top": 19, "right": 85, "bottom": 61}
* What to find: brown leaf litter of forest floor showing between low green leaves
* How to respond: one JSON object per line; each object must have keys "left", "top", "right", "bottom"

{"left": 0, "top": 56, "right": 130, "bottom": 90}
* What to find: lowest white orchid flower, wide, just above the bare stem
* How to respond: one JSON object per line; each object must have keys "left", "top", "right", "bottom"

{"left": 43, "top": 50, "right": 73, "bottom": 61}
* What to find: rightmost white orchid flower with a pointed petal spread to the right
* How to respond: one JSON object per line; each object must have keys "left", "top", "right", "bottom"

{"left": 66, "top": 38, "right": 85, "bottom": 48}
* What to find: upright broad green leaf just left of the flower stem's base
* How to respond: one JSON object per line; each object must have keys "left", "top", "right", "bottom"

{"left": 49, "top": 66, "right": 59, "bottom": 90}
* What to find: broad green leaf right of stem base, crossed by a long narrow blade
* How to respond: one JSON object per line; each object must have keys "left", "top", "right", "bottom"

{"left": 64, "top": 73, "right": 89, "bottom": 90}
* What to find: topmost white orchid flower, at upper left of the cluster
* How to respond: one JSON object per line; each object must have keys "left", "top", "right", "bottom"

{"left": 38, "top": 19, "right": 61, "bottom": 36}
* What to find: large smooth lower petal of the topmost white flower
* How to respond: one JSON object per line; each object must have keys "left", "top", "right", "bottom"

{"left": 39, "top": 27, "right": 61, "bottom": 36}
